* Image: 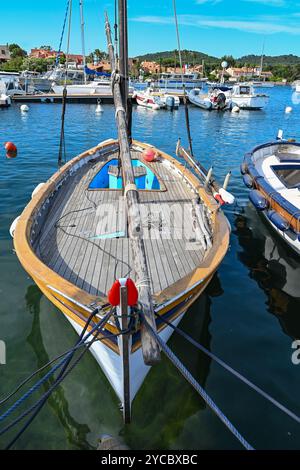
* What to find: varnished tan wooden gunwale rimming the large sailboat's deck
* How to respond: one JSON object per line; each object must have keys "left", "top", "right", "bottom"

{"left": 14, "top": 139, "right": 230, "bottom": 316}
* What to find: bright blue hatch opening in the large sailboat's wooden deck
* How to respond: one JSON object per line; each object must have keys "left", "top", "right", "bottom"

{"left": 89, "top": 159, "right": 161, "bottom": 191}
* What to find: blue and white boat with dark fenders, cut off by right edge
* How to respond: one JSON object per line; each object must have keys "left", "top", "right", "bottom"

{"left": 241, "top": 141, "right": 300, "bottom": 254}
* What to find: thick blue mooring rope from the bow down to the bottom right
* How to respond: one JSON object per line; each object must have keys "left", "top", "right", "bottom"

{"left": 143, "top": 318, "right": 254, "bottom": 450}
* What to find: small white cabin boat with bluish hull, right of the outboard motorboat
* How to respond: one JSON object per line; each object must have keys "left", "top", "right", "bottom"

{"left": 225, "top": 84, "right": 269, "bottom": 110}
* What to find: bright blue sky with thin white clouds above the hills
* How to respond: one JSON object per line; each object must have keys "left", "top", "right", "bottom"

{"left": 0, "top": 0, "right": 300, "bottom": 57}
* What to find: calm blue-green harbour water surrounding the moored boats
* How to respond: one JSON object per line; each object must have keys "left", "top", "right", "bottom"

{"left": 0, "top": 88, "right": 300, "bottom": 449}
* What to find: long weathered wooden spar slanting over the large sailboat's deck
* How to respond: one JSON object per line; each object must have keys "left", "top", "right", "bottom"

{"left": 105, "top": 11, "right": 160, "bottom": 366}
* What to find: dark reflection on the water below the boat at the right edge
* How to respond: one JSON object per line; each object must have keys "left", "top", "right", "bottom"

{"left": 234, "top": 206, "right": 300, "bottom": 339}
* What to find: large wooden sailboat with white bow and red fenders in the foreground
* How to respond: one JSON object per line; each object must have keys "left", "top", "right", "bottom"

{"left": 14, "top": 0, "right": 230, "bottom": 422}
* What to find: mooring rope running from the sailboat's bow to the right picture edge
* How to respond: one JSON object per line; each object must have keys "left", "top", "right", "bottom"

{"left": 157, "top": 315, "right": 300, "bottom": 423}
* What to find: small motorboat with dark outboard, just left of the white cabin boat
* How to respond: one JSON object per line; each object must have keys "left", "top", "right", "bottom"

{"left": 188, "top": 87, "right": 232, "bottom": 111}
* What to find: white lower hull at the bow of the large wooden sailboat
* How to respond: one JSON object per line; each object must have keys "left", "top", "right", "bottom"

{"left": 65, "top": 312, "right": 185, "bottom": 405}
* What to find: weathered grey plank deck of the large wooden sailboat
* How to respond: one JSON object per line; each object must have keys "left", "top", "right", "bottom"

{"left": 35, "top": 152, "right": 209, "bottom": 295}
